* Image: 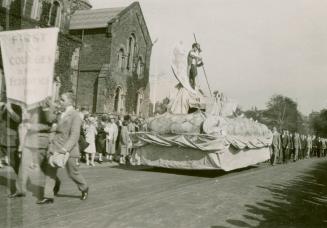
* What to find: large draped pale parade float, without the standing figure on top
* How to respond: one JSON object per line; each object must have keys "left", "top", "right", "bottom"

{"left": 131, "top": 41, "right": 272, "bottom": 171}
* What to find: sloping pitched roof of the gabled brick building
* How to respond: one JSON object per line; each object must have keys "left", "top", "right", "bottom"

{"left": 69, "top": 7, "right": 126, "bottom": 30}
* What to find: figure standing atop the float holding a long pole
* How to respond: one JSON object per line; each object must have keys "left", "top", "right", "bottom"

{"left": 187, "top": 43, "right": 203, "bottom": 89}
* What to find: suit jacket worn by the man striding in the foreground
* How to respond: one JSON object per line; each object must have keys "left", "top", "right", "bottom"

{"left": 49, "top": 110, "right": 82, "bottom": 158}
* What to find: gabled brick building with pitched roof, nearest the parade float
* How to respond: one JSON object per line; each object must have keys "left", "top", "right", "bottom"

{"left": 69, "top": 2, "right": 152, "bottom": 116}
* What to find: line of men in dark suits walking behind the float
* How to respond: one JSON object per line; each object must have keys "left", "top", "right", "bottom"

{"left": 271, "top": 127, "right": 327, "bottom": 165}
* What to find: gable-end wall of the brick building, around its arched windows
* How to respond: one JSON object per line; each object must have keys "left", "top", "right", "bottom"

{"left": 98, "top": 3, "right": 152, "bottom": 116}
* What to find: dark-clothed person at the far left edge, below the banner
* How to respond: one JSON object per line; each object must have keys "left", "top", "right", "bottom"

{"left": 0, "top": 102, "right": 22, "bottom": 174}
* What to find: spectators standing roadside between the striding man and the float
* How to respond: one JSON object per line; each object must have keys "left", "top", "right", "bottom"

{"left": 82, "top": 115, "right": 144, "bottom": 166}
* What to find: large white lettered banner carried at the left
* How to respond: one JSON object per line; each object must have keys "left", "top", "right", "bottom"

{"left": 0, "top": 28, "right": 59, "bottom": 108}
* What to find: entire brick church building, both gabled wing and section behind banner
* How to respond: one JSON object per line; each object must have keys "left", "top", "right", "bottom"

{"left": 0, "top": 0, "right": 152, "bottom": 117}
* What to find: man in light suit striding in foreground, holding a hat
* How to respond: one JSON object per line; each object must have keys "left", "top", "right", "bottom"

{"left": 37, "top": 92, "right": 89, "bottom": 204}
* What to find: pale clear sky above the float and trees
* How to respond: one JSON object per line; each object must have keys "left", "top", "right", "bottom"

{"left": 90, "top": 0, "right": 327, "bottom": 114}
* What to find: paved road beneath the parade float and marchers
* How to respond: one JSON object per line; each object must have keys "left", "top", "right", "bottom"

{"left": 0, "top": 158, "right": 327, "bottom": 228}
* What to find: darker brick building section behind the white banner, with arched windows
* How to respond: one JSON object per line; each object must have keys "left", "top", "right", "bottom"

{"left": 0, "top": 0, "right": 91, "bottom": 100}
